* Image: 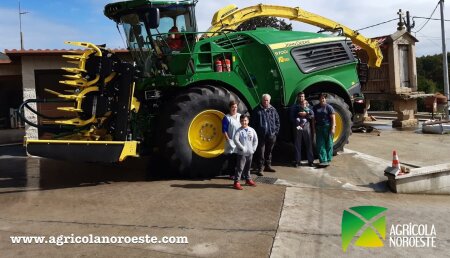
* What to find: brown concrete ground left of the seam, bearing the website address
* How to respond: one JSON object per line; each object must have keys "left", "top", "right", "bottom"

{"left": 0, "top": 159, "right": 285, "bottom": 257}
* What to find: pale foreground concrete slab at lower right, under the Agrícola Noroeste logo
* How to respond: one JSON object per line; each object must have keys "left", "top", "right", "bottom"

{"left": 271, "top": 187, "right": 450, "bottom": 258}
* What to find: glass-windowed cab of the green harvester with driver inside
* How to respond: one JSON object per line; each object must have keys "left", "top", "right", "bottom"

{"left": 105, "top": 0, "right": 197, "bottom": 77}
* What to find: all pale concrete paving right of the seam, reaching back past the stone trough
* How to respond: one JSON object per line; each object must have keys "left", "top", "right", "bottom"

{"left": 271, "top": 121, "right": 450, "bottom": 257}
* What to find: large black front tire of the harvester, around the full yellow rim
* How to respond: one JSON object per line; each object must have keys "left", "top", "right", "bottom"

{"left": 159, "top": 85, "right": 247, "bottom": 177}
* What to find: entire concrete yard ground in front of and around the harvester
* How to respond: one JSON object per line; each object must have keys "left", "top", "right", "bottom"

{"left": 0, "top": 121, "right": 450, "bottom": 257}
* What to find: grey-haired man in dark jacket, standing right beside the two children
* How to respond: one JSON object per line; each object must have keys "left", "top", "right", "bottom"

{"left": 251, "top": 94, "right": 280, "bottom": 176}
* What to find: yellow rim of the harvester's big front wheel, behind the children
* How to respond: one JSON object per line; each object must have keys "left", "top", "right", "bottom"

{"left": 188, "top": 110, "right": 225, "bottom": 158}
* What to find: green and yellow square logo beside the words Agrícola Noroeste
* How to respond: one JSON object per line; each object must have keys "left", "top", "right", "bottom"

{"left": 341, "top": 206, "right": 387, "bottom": 252}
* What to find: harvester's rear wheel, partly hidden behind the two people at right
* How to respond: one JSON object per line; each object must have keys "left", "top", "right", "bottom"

{"left": 312, "top": 93, "right": 352, "bottom": 155}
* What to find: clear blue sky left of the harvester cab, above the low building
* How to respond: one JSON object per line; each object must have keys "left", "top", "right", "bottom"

{"left": 0, "top": 0, "right": 123, "bottom": 49}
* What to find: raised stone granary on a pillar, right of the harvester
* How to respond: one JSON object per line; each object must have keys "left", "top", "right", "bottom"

{"left": 356, "top": 29, "right": 427, "bottom": 127}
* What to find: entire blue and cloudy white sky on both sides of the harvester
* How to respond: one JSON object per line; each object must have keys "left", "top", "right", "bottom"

{"left": 0, "top": 0, "right": 450, "bottom": 56}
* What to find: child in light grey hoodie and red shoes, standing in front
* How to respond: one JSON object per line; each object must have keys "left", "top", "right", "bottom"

{"left": 233, "top": 115, "right": 258, "bottom": 190}
